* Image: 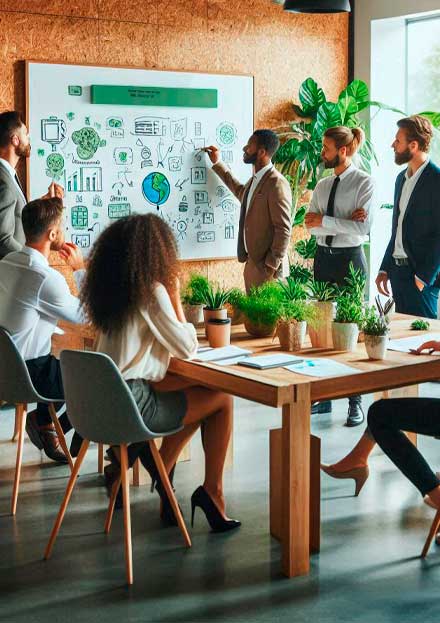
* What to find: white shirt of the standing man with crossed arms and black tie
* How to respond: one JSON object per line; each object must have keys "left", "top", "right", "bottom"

{"left": 309, "top": 163, "right": 374, "bottom": 248}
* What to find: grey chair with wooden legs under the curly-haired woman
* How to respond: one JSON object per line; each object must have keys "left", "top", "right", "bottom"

{"left": 44, "top": 350, "right": 191, "bottom": 584}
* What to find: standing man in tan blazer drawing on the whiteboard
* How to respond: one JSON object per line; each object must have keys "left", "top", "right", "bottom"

{"left": 205, "top": 130, "right": 292, "bottom": 292}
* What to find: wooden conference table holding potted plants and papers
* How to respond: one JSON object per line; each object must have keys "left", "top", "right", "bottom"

{"left": 55, "top": 315, "right": 440, "bottom": 577}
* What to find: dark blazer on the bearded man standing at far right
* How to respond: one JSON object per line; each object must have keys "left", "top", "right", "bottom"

{"left": 380, "top": 162, "right": 440, "bottom": 286}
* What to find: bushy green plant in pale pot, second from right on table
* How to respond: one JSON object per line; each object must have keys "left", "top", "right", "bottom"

{"left": 332, "top": 292, "right": 362, "bottom": 352}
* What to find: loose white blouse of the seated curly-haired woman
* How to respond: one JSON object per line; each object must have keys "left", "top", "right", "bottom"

{"left": 96, "top": 284, "right": 198, "bottom": 381}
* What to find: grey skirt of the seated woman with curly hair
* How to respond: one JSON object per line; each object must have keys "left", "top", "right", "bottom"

{"left": 127, "top": 379, "right": 187, "bottom": 433}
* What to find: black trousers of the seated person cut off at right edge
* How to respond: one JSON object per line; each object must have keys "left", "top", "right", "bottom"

{"left": 368, "top": 398, "right": 440, "bottom": 496}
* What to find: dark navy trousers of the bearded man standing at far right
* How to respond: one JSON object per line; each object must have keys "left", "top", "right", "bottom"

{"left": 388, "top": 265, "right": 439, "bottom": 318}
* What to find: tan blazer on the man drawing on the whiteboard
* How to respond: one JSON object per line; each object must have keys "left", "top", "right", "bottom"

{"left": 213, "top": 162, "right": 292, "bottom": 290}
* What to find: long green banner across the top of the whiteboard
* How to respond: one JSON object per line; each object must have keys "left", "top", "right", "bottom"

{"left": 92, "top": 84, "right": 218, "bottom": 108}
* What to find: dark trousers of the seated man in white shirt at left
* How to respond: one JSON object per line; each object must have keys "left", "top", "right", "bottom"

{"left": 26, "top": 355, "right": 72, "bottom": 433}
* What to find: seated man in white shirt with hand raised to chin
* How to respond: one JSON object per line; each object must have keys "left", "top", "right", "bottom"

{"left": 0, "top": 198, "right": 84, "bottom": 463}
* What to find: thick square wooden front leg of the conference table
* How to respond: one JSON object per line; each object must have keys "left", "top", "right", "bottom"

{"left": 281, "top": 383, "right": 310, "bottom": 578}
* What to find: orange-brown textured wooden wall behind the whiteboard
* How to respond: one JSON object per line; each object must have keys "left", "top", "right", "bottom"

{"left": 0, "top": 0, "right": 348, "bottom": 286}
